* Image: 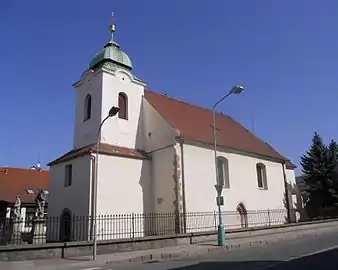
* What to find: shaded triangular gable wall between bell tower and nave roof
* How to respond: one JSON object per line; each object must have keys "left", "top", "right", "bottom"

{"left": 140, "top": 98, "right": 178, "bottom": 152}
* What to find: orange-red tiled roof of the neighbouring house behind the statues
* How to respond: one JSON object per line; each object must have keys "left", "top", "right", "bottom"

{"left": 0, "top": 167, "right": 49, "bottom": 203}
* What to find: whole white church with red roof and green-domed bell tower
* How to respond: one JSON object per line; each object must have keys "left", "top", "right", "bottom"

{"left": 47, "top": 16, "right": 295, "bottom": 240}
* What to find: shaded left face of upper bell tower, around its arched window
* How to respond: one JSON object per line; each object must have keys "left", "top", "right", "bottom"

{"left": 74, "top": 72, "right": 102, "bottom": 148}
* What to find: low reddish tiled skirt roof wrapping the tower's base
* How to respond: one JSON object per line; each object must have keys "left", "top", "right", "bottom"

{"left": 48, "top": 143, "right": 148, "bottom": 166}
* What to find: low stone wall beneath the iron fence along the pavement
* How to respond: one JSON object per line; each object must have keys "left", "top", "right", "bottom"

{"left": 0, "top": 219, "right": 338, "bottom": 261}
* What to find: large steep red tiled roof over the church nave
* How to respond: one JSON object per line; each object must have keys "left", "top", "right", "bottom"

{"left": 145, "top": 90, "right": 295, "bottom": 168}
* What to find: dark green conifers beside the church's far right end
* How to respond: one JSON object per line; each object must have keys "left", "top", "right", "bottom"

{"left": 300, "top": 133, "right": 338, "bottom": 208}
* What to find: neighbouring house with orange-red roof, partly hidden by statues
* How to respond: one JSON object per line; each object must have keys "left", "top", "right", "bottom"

{"left": 0, "top": 167, "right": 49, "bottom": 230}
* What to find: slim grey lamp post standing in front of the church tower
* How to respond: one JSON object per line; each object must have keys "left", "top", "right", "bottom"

{"left": 92, "top": 106, "right": 120, "bottom": 260}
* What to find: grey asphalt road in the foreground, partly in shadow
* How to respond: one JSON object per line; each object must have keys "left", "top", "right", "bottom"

{"left": 97, "top": 230, "right": 338, "bottom": 270}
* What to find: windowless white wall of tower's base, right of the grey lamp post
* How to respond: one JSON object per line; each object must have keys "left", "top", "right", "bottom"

{"left": 97, "top": 155, "right": 154, "bottom": 240}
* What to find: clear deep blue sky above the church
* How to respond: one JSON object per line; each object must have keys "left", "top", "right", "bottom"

{"left": 0, "top": 0, "right": 338, "bottom": 175}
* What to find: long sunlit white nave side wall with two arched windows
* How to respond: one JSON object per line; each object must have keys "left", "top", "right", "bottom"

{"left": 184, "top": 144, "right": 286, "bottom": 230}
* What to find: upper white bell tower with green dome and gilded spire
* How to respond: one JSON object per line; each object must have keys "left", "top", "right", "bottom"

{"left": 74, "top": 15, "right": 146, "bottom": 149}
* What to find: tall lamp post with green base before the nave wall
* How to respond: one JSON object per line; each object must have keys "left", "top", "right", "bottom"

{"left": 212, "top": 85, "right": 244, "bottom": 246}
